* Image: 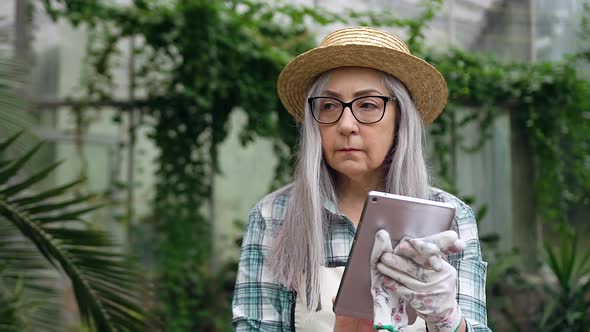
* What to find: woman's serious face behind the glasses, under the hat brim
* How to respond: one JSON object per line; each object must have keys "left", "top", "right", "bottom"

{"left": 318, "top": 67, "right": 396, "bottom": 183}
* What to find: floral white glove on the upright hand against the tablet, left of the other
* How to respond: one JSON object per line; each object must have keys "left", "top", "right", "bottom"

{"left": 370, "top": 229, "right": 408, "bottom": 332}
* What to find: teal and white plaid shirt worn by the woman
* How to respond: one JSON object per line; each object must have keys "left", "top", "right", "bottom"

{"left": 232, "top": 188, "right": 490, "bottom": 332}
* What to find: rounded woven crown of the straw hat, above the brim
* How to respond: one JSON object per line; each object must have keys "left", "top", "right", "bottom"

{"left": 320, "top": 27, "right": 411, "bottom": 54}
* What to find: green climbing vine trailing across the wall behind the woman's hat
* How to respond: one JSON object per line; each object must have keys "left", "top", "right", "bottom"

{"left": 42, "top": 0, "right": 590, "bottom": 331}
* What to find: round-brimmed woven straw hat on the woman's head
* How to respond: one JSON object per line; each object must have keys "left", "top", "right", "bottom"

{"left": 277, "top": 27, "right": 447, "bottom": 124}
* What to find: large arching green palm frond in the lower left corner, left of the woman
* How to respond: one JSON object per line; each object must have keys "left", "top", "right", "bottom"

{"left": 0, "top": 136, "right": 145, "bottom": 331}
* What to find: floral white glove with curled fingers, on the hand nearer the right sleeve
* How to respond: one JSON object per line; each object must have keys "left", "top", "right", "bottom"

{"left": 376, "top": 231, "right": 465, "bottom": 332}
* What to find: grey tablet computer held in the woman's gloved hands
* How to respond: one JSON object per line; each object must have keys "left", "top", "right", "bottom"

{"left": 333, "top": 191, "right": 455, "bottom": 322}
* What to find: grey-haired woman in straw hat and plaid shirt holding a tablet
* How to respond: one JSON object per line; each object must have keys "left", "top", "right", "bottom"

{"left": 233, "top": 27, "right": 489, "bottom": 331}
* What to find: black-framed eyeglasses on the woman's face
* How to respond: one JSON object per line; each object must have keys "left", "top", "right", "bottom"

{"left": 307, "top": 96, "right": 396, "bottom": 124}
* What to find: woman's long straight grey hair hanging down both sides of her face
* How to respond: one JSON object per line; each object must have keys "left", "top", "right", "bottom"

{"left": 269, "top": 71, "right": 430, "bottom": 311}
